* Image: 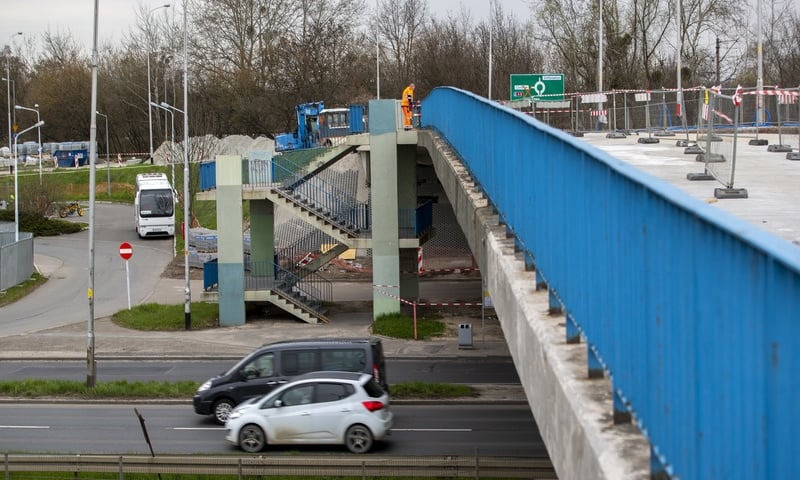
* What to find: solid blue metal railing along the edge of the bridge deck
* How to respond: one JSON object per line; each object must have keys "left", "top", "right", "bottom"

{"left": 423, "top": 88, "right": 800, "bottom": 479}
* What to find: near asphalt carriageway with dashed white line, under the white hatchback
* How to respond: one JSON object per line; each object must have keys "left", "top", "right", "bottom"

{"left": 0, "top": 404, "right": 547, "bottom": 458}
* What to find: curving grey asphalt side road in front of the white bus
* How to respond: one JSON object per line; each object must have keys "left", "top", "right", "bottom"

{"left": 0, "top": 204, "right": 172, "bottom": 336}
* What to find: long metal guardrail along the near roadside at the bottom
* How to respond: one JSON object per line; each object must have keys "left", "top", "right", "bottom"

{"left": 3, "top": 453, "right": 556, "bottom": 479}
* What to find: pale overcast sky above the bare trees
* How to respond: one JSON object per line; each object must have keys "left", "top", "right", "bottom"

{"left": 0, "top": 0, "right": 530, "bottom": 53}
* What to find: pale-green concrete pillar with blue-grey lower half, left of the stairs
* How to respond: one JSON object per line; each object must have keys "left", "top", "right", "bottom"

{"left": 216, "top": 155, "right": 246, "bottom": 327}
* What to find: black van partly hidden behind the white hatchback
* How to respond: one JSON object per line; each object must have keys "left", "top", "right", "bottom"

{"left": 193, "top": 337, "right": 389, "bottom": 424}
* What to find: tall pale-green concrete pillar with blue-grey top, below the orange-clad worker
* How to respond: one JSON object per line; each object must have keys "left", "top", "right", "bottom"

{"left": 369, "top": 100, "right": 400, "bottom": 318}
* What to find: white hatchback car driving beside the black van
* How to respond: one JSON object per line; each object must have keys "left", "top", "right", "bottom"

{"left": 225, "top": 372, "right": 394, "bottom": 453}
